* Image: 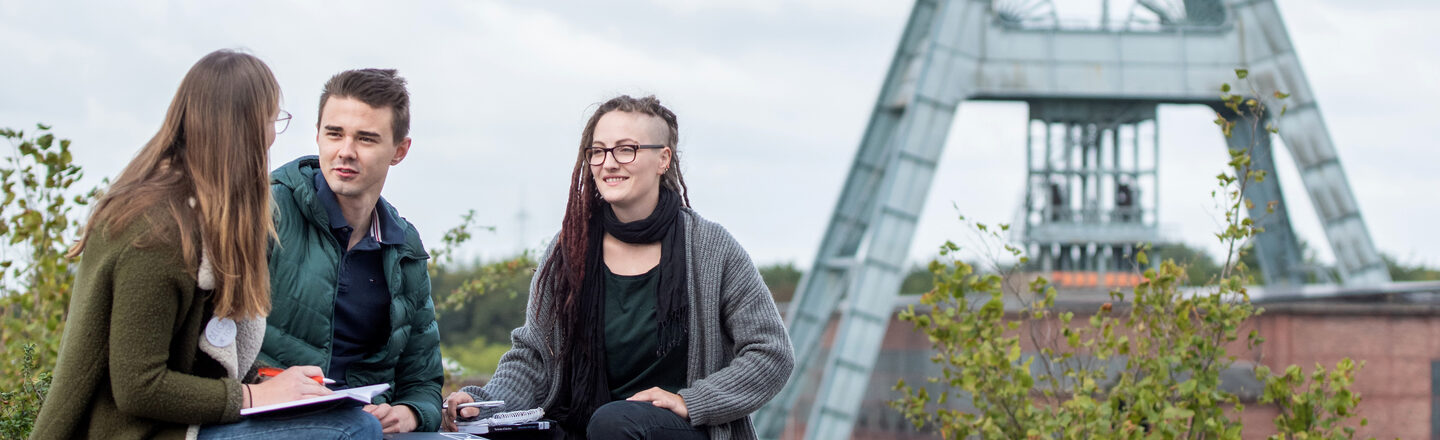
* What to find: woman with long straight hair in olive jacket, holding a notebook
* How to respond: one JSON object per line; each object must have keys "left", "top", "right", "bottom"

{"left": 33, "top": 50, "right": 380, "bottom": 439}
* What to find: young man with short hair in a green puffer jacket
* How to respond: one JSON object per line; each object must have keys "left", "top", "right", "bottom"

{"left": 261, "top": 69, "right": 444, "bottom": 433}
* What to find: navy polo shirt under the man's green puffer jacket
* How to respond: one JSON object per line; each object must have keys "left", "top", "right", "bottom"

{"left": 315, "top": 173, "right": 405, "bottom": 388}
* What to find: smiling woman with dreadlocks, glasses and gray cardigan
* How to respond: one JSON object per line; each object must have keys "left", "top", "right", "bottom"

{"left": 445, "top": 96, "right": 795, "bottom": 440}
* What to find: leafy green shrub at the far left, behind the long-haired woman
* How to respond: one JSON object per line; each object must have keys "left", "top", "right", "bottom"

{"left": 0, "top": 124, "right": 98, "bottom": 439}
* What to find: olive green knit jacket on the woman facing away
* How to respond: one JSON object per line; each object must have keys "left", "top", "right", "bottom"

{"left": 30, "top": 210, "right": 242, "bottom": 439}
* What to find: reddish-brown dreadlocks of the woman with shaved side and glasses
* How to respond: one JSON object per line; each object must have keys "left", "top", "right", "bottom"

{"left": 540, "top": 95, "right": 690, "bottom": 331}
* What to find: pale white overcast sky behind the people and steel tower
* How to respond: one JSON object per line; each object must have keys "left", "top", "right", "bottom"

{"left": 0, "top": 0, "right": 1440, "bottom": 274}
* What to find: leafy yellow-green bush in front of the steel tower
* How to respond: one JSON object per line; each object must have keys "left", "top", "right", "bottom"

{"left": 893, "top": 69, "right": 1365, "bottom": 439}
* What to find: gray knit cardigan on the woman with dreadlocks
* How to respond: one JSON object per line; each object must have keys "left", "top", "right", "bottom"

{"left": 461, "top": 208, "right": 795, "bottom": 440}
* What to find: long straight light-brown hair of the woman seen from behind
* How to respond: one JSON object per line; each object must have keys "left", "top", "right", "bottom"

{"left": 69, "top": 49, "right": 281, "bottom": 318}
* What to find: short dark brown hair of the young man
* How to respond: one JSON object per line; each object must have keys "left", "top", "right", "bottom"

{"left": 315, "top": 69, "right": 410, "bottom": 142}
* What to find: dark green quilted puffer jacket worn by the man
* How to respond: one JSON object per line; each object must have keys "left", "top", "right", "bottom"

{"left": 259, "top": 155, "right": 445, "bottom": 431}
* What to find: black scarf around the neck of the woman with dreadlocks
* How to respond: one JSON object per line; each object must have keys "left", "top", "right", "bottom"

{"left": 556, "top": 188, "right": 690, "bottom": 433}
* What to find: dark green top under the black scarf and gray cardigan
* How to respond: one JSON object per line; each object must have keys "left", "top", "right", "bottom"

{"left": 605, "top": 266, "right": 690, "bottom": 400}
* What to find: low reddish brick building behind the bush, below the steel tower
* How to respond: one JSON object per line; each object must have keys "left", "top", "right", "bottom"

{"left": 782, "top": 282, "right": 1440, "bottom": 439}
